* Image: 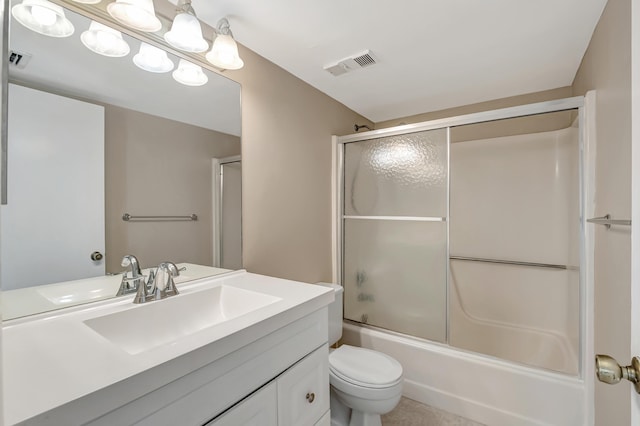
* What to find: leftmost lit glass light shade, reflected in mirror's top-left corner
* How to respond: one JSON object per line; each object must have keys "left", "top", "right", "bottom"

{"left": 11, "top": 0, "right": 75, "bottom": 37}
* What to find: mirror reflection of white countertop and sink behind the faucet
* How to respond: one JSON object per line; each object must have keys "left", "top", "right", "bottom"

{"left": 2, "top": 263, "right": 232, "bottom": 320}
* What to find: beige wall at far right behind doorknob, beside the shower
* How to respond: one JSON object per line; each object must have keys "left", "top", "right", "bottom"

{"left": 573, "top": 0, "right": 631, "bottom": 425}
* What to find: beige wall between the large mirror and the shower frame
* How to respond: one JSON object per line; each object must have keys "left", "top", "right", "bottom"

{"left": 228, "top": 47, "right": 371, "bottom": 282}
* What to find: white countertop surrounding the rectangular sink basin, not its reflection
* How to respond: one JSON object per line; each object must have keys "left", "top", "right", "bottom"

{"left": 2, "top": 271, "right": 334, "bottom": 425}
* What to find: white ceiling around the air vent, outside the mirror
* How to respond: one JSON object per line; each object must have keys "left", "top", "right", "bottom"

{"left": 192, "top": 0, "right": 606, "bottom": 122}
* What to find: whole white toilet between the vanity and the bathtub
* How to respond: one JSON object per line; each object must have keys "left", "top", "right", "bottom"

{"left": 318, "top": 283, "right": 402, "bottom": 426}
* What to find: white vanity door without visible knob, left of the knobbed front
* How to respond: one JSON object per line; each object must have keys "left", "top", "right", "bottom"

{"left": 205, "top": 382, "right": 278, "bottom": 426}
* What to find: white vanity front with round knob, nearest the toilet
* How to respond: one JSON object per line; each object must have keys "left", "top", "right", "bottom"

{"left": 276, "top": 345, "right": 329, "bottom": 426}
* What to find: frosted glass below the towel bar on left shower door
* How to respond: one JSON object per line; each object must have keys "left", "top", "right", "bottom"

{"left": 344, "top": 219, "right": 447, "bottom": 342}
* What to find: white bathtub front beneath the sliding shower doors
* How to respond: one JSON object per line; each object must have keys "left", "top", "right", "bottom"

{"left": 343, "top": 321, "right": 587, "bottom": 426}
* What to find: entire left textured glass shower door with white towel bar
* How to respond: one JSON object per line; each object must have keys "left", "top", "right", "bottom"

{"left": 342, "top": 129, "right": 449, "bottom": 342}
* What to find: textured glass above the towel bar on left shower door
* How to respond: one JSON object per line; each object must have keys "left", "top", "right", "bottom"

{"left": 344, "top": 129, "right": 448, "bottom": 217}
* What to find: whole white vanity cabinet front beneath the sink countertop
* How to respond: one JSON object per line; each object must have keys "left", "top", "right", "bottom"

{"left": 79, "top": 308, "right": 329, "bottom": 426}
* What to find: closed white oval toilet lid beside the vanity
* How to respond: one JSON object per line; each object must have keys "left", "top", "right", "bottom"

{"left": 329, "top": 345, "right": 402, "bottom": 387}
